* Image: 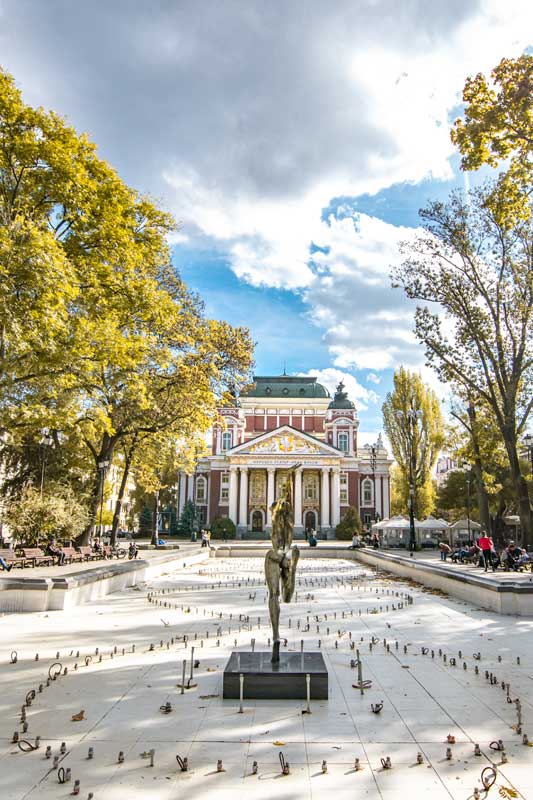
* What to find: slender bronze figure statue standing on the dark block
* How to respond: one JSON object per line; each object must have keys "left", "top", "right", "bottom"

{"left": 265, "top": 464, "right": 300, "bottom": 663}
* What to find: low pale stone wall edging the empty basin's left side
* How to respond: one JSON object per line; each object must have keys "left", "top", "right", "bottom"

{"left": 0, "top": 548, "right": 208, "bottom": 612}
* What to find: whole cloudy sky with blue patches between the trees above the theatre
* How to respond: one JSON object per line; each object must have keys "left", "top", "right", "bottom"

{"left": 0, "top": 0, "right": 533, "bottom": 443}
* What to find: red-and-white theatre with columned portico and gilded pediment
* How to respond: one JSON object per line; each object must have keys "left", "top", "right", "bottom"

{"left": 178, "top": 375, "right": 392, "bottom": 538}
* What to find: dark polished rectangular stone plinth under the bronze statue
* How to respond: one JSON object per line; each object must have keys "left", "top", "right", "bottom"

{"left": 223, "top": 651, "right": 328, "bottom": 700}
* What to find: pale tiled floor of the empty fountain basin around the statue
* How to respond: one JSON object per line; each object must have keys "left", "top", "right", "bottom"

{"left": 0, "top": 558, "right": 533, "bottom": 800}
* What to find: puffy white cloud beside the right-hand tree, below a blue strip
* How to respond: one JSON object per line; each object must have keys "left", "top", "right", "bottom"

{"left": 304, "top": 214, "right": 424, "bottom": 371}
